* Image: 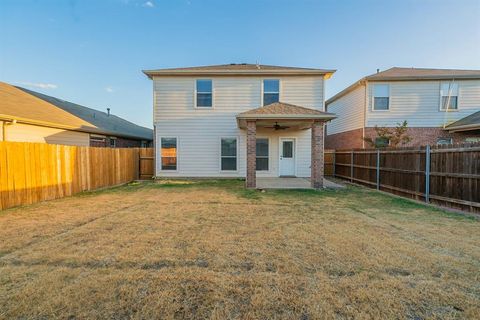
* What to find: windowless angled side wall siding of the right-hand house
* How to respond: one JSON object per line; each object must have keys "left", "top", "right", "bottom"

{"left": 327, "top": 85, "right": 365, "bottom": 134}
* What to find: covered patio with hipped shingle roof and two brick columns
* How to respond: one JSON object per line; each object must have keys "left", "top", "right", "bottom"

{"left": 237, "top": 102, "right": 335, "bottom": 189}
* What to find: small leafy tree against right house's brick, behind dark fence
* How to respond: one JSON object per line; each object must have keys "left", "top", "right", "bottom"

{"left": 363, "top": 120, "right": 412, "bottom": 148}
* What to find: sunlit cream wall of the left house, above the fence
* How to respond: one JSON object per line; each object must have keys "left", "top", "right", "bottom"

{"left": 5, "top": 123, "right": 90, "bottom": 146}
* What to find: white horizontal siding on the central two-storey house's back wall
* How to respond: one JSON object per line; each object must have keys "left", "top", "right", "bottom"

{"left": 154, "top": 77, "right": 323, "bottom": 177}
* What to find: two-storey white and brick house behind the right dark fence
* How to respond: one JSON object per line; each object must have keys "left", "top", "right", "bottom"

{"left": 325, "top": 68, "right": 480, "bottom": 149}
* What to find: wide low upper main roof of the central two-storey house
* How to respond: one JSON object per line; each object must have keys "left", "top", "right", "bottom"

{"left": 143, "top": 63, "right": 336, "bottom": 79}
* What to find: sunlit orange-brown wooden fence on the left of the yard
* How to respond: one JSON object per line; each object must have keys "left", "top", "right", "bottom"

{"left": 0, "top": 142, "right": 154, "bottom": 209}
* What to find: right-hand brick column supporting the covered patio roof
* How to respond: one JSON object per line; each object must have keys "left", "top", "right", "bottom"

{"left": 310, "top": 120, "right": 324, "bottom": 189}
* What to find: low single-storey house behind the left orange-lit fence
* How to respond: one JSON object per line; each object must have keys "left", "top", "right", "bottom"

{"left": 0, "top": 82, "right": 153, "bottom": 148}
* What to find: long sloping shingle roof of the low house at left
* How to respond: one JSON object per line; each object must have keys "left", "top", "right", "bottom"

{"left": 0, "top": 82, "right": 153, "bottom": 140}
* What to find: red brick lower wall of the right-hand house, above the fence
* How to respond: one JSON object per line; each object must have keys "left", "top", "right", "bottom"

{"left": 325, "top": 127, "right": 480, "bottom": 149}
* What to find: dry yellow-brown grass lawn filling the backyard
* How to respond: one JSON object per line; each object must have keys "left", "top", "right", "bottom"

{"left": 0, "top": 181, "right": 480, "bottom": 319}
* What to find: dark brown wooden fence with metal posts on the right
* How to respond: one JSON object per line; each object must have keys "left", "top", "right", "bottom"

{"left": 326, "top": 145, "right": 480, "bottom": 212}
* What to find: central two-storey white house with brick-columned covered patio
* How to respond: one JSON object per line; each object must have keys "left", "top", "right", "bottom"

{"left": 144, "top": 64, "right": 334, "bottom": 188}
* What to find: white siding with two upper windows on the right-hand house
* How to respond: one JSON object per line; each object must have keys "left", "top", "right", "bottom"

{"left": 366, "top": 80, "right": 480, "bottom": 127}
